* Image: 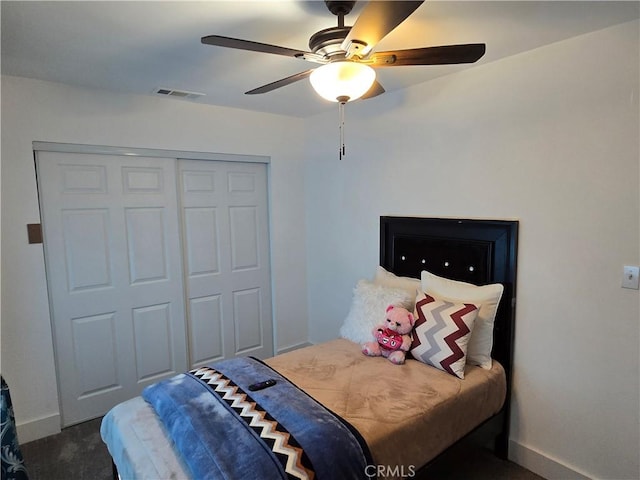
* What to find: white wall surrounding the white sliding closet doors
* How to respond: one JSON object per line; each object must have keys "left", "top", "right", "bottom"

{"left": 2, "top": 76, "right": 308, "bottom": 442}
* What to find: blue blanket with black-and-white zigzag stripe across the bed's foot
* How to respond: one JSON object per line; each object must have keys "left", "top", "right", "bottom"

{"left": 142, "top": 358, "right": 373, "bottom": 480}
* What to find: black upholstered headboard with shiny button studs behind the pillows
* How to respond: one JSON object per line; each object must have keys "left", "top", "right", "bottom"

{"left": 380, "top": 217, "right": 518, "bottom": 386}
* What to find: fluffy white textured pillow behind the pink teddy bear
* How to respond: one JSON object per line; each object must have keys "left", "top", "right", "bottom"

{"left": 340, "top": 280, "right": 415, "bottom": 344}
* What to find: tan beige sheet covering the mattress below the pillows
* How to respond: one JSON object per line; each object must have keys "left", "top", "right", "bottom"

{"left": 265, "top": 339, "right": 506, "bottom": 469}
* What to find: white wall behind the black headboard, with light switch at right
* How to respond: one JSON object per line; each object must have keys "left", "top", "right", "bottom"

{"left": 305, "top": 21, "right": 640, "bottom": 480}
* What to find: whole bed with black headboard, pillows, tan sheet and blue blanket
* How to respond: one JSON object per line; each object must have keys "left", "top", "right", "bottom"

{"left": 101, "top": 217, "right": 518, "bottom": 479}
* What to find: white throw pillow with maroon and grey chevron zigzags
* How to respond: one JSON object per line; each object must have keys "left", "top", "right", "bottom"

{"left": 411, "top": 293, "right": 479, "bottom": 378}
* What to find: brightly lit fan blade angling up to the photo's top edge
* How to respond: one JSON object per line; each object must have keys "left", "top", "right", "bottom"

{"left": 342, "top": 0, "right": 424, "bottom": 58}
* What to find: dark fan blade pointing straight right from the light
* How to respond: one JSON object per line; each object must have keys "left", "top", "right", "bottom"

{"left": 366, "top": 43, "right": 486, "bottom": 67}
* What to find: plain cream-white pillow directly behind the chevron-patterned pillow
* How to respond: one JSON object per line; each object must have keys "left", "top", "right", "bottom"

{"left": 421, "top": 270, "right": 504, "bottom": 370}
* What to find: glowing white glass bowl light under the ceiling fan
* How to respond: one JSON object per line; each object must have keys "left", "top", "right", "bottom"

{"left": 309, "top": 61, "right": 376, "bottom": 102}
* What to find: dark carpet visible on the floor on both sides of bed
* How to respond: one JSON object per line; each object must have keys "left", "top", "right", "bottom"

{"left": 21, "top": 418, "right": 544, "bottom": 480}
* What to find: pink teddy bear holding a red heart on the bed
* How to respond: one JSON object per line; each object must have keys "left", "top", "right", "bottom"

{"left": 362, "top": 305, "right": 415, "bottom": 365}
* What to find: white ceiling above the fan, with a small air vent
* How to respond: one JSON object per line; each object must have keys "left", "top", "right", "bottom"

{"left": 1, "top": 0, "right": 640, "bottom": 117}
